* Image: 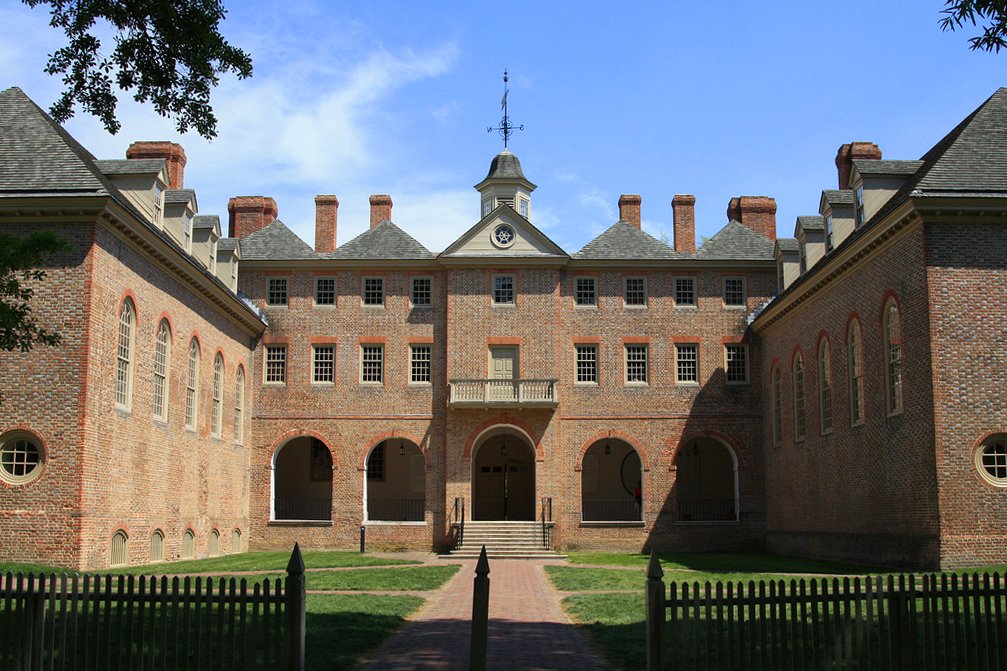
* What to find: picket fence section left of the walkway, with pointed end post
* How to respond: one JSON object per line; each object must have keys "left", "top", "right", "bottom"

{"left": 0, "top": 545, "right": 305, "bottom": 671}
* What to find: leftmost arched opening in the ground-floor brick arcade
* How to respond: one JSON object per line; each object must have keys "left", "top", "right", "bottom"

{"left": 271, "top": 436, "right": 332, "bottom": 520}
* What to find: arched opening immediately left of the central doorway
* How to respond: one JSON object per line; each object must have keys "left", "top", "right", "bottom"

{"left": 364, "top": 438, "right": 427, "bottom": 522}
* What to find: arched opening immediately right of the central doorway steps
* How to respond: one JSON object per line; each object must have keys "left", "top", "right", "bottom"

{"left": 580, "top": 438, "right": 643, "bottom": 522}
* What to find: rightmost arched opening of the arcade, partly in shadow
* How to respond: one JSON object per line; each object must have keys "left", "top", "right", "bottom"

{"left": 675, "top": 437, "right": 738, "bottom": 522}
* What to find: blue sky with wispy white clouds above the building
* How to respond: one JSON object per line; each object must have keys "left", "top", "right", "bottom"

{"left": 0, "top": 0, "right": 1007, "bottom": 253}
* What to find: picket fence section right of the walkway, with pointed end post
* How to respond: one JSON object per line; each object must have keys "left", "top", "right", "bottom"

{"left": 646, "top": 557, "right": 1007, "bottom": 671}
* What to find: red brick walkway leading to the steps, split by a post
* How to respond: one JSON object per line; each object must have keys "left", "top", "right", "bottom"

{"left": 365, "top": 559, "right": 603, "bottom": 671}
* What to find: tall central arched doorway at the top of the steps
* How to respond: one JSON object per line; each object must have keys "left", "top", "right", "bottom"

{"left": 472, "top": 428, "right": 535, "bottom": 520}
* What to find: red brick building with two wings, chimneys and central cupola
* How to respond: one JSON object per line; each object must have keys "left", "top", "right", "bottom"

{"left": 0, "top": 82, "right": 1007, "bottom": 567}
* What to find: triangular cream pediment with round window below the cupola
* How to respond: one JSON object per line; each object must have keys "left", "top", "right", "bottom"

{"left": 440, "top": 205, "right": 569, "bottom": 258}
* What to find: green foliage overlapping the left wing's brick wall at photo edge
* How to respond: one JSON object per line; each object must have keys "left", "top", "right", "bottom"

{"left": 0, "top": 231, "right": 66, "bottom": 352}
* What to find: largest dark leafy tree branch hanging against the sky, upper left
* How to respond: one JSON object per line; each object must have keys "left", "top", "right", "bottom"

{"left": 22, "top": 0, "right": 252, "bottom": 139}
